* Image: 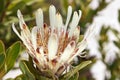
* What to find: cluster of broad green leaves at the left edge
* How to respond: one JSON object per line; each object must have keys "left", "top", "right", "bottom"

{"left": 0, "top": 40, "right": 21, "bottom": 79}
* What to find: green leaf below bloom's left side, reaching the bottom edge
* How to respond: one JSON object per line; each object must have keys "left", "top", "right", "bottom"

{"left": 20, "top": 61, "right": 35, "bottom": 80}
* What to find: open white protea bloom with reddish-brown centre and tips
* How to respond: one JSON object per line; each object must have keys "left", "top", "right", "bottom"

{"left": 12, "top": 5, "right": 92, "bottom": 75}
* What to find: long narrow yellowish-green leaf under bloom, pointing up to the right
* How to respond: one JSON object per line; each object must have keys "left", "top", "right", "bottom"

{"left": 61, "top": 61, "right": 91, "bottom": 80}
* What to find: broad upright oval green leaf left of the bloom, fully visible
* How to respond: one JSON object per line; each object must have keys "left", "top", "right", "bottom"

{"left": 6, "top": 42, "right": 21, "bottom": 72}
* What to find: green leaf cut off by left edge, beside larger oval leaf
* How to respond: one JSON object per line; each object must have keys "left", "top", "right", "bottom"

{"left": 0, "top": 40, "right": 5, "bottom": 68}
